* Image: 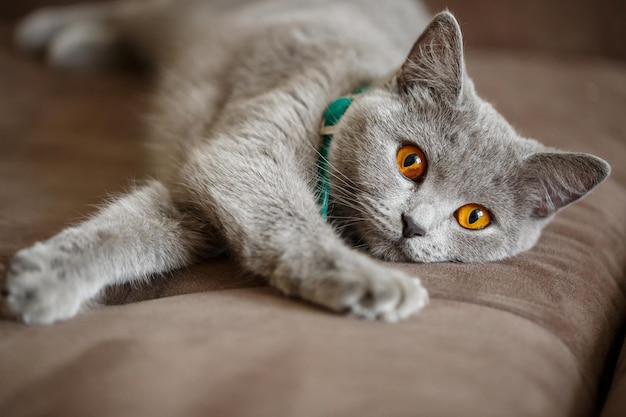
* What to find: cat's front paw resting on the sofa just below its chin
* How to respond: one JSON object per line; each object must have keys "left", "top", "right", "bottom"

{"left": 302, "top": 258, "right": 428, "bottom": 322}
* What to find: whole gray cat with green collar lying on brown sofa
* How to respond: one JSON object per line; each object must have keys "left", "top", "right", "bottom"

{"left": 4, "top": 0, "right": 609, "bottom": 324}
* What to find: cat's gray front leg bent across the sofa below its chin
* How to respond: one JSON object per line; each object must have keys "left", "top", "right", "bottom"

{"left": 180, "top": 141, "right": 428, "bottom": 321}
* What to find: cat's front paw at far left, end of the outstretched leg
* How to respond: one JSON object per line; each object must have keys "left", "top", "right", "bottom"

{"left": 2, "top": 243, "right": 84, "bottom": 324}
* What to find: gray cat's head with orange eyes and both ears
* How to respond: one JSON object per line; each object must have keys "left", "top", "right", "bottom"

{"left": 329, "top": 12, "right": 610, "bottom": 262}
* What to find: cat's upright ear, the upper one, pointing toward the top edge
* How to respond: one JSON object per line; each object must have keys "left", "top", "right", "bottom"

{"left": 397, "top": 11, "right": 465, "bottom": 104}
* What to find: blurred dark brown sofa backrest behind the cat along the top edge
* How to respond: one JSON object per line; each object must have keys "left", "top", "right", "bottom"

{"left": 0, "top": 0, "right": 626, "bottom": 59}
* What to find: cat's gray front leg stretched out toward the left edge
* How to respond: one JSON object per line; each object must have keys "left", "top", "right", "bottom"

{"left": 3, "top": 181, "right": 215, "bottom": 324}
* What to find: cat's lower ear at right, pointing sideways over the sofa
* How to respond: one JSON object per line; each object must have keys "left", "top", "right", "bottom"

{"left": 524, "top": 152, "right": 611, "bottom": 218}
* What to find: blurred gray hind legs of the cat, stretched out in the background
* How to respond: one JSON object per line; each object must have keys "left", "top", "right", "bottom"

{"left": 15, "top": 0, "right": 177, "bottom": 70}
